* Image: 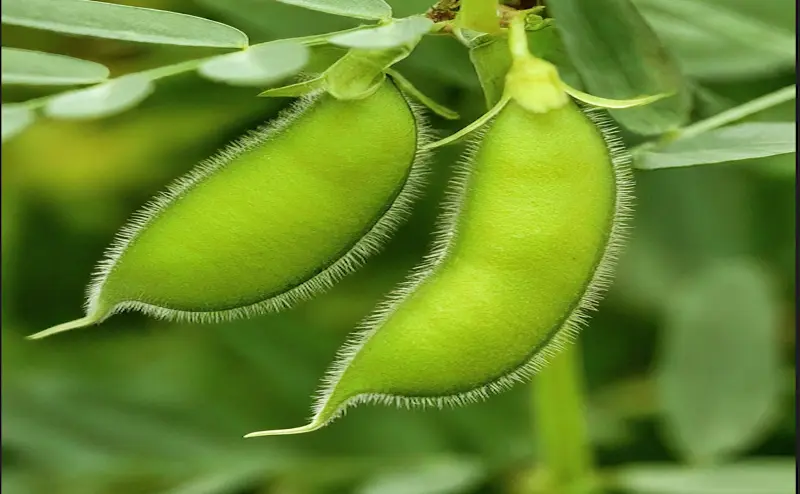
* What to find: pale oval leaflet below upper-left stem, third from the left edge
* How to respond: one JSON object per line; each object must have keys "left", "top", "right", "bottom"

{"left": 198, "top": 40, "right": 309, "bottom": 86}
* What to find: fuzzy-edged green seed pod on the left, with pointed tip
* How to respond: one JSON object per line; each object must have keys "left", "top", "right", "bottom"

{"left": 32, "top": 77, "right": 427, "bottom": 338}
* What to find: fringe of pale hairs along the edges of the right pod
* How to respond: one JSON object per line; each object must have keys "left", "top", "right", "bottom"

{"left": 284, "top": 104, "right": 634, "bottom": 436}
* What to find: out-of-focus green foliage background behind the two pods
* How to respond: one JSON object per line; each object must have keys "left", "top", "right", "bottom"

{"left": 1, "top": 0, "right": 796, "bottom": 494}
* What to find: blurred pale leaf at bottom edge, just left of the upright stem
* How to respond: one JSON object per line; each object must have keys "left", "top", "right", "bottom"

{"left": 355, "top": 458, "right": 486, "bottom": 494}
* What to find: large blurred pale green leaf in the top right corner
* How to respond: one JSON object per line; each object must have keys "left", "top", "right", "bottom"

{"left": 634, "top": 0, "right": 796, "bottom": 78}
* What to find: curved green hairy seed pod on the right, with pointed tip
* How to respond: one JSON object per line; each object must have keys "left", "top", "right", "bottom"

{"left": 249, "top": 100, "right": 632, "bottom": 436}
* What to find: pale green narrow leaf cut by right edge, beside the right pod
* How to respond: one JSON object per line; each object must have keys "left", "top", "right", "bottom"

{"left": 636, "top": 122, "right": 797, "bottom": 170}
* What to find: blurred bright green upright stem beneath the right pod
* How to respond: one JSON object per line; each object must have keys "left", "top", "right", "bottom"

{"left": 533, "top": 343, "right": 594, "bottom": 494}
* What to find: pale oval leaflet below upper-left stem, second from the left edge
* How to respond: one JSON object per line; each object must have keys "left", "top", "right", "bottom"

{"left": 44, "top": 75, "right": 155, "bottom": 119}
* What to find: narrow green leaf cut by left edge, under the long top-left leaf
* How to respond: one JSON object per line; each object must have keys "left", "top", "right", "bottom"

{"left": 2, "top": 47, "right": 108, "bottom": 86}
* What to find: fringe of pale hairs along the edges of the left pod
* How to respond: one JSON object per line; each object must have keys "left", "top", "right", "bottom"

{"left": 84, "top": 82, "right": 435, "bottom": 323}
